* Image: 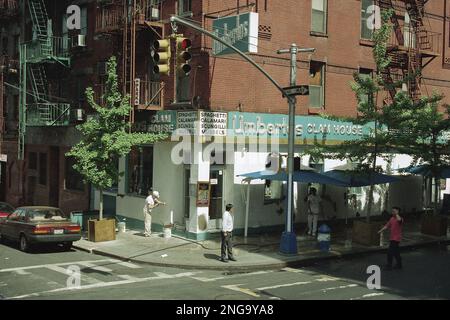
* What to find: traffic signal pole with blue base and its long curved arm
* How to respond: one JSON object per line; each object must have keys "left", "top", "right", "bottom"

{"left": 170, "top": 16, "right": 315, "bottom": 254}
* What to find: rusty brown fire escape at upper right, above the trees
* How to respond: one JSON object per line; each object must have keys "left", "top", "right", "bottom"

{"left": 378, "top": 0, "right": 442, "bottom": 103}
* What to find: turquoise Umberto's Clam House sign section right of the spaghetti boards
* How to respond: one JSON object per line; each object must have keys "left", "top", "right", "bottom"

{"left": 228, "top": 112, "right": 370, "bottom": 143}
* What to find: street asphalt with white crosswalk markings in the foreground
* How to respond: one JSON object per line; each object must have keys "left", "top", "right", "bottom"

{"left": 0, "top": 243, "right": 450, "bottom": 300}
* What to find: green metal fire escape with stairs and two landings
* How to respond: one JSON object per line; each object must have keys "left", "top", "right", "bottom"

{"left": 19, "top": 0, "right": 70, "bottom": 159}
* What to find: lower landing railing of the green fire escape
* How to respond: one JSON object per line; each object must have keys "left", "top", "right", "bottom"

{"left": 27, "top": 103, "right": 71, "bottom": 127}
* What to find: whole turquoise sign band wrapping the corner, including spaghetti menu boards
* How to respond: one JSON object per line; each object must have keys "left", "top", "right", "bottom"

{"left": 133, "top": 110, "right": 371, "bottom": 144}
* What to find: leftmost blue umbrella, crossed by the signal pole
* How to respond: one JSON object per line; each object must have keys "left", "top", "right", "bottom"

{"left": 239, "top": 170, "right": 347, "bottom": 187}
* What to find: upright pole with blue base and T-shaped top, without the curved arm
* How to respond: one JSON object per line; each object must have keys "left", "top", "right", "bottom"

{"left": 277, "top": 43, "right": 315, "bottom": 254}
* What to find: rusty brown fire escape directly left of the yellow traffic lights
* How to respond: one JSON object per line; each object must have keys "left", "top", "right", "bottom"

{"left": 96, "top": 0, "right": 164, "bottom": 123}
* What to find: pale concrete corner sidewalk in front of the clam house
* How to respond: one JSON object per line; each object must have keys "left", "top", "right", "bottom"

{"left": 74, "top": 218, "right": 450, "bottom": 271}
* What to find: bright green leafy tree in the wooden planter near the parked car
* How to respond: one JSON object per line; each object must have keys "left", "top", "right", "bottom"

{"left": 66, "top": 57, "right": 165, "bottom": 220}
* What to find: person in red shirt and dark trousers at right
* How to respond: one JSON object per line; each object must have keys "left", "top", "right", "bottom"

{"left": 378, "top": 207, "right": 403, "bottom": 270}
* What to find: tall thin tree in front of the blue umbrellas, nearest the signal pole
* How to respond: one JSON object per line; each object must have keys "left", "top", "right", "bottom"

{"left": 308, "top": 11, "right": 401, "bottom": 222}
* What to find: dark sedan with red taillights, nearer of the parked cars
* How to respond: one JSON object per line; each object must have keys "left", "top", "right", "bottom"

{"left": 0, "top": 207, "right": 81, "bottom": 251}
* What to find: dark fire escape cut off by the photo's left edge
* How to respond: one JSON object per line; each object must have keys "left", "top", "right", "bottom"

{"left": 0, "top": 0, "right": 19, "bottom": 140}
